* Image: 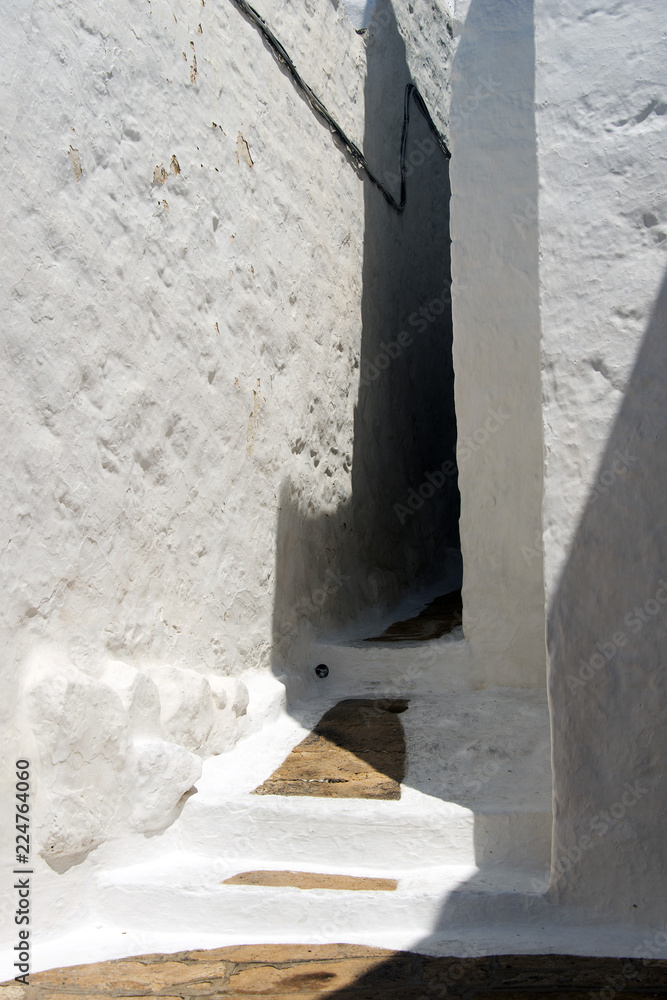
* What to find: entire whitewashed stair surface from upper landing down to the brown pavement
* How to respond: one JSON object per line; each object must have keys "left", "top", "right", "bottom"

{"left": 0, "top": 691, "right": 667, "bottom": 975}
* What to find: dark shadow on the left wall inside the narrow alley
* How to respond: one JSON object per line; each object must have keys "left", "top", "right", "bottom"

{"left": 274, "top": 0, "right": 460, "bottom": 688}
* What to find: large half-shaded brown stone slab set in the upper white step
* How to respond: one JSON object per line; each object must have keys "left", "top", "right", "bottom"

{"left": 255, "top": 698, "right": 408, "bottom": 799}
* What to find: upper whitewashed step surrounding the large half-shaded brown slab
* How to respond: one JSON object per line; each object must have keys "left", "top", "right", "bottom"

{"left": 151, "top": 689, "right": 551, "bottom": 871}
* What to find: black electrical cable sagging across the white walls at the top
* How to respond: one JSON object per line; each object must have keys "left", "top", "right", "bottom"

{"left": 227, "top": 0, "right": 451, "bottom": 214}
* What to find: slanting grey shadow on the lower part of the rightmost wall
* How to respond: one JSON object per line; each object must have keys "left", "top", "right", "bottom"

{"left": 547, "top": 266, "right": 667, "bottom": 926}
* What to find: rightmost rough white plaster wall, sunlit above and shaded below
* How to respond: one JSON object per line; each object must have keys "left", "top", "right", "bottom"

{"left": 535, "top": 0, "right": 667, "bottom": 927}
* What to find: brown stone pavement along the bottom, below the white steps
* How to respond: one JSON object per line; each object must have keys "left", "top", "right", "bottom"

{"left": 0, "top": 944, "right": 667, "bottom": 1000}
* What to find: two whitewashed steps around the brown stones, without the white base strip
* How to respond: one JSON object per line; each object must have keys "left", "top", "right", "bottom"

{"left": 91, "top": 685, "right": 551, "bottom": 947}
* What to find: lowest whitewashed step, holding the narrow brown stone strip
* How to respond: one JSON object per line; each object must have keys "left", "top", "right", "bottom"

{"left": 96, "top": 854, "right": 544, "bottom": 942}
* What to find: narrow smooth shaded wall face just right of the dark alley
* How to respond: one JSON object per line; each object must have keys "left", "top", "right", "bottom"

{"left": 451, "top": 0, "right": 545, "bottom": 687}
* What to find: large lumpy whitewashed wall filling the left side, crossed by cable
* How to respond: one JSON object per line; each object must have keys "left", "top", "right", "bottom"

{"left": 0, "top": 0, "right": 451, "bottom": 866}
